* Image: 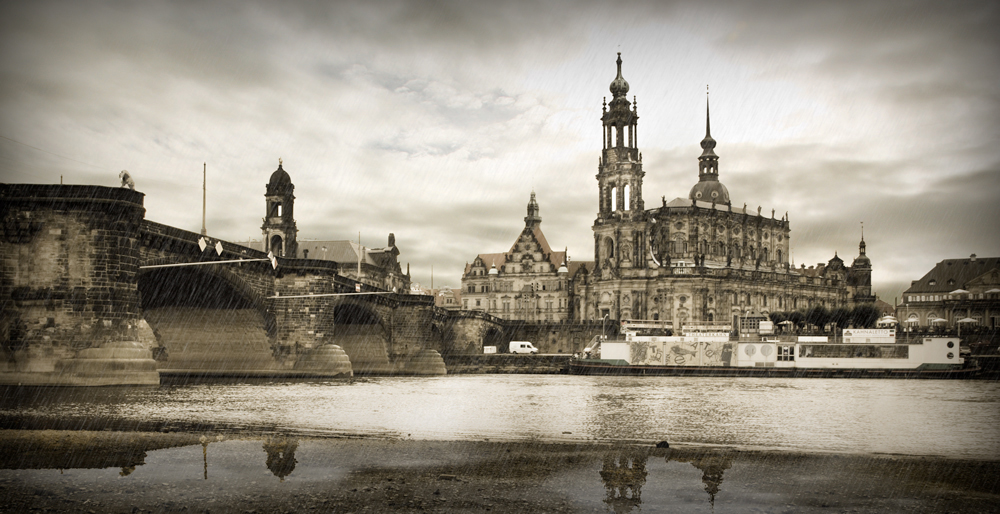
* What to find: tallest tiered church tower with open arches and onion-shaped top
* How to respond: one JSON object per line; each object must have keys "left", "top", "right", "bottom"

{"left": 594, "top": 52, "right": 645, "bottom": 278}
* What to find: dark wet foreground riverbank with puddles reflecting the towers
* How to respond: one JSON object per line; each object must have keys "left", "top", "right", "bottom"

{"left": 0, "top": 430, "right": 1000, "bottom": 513}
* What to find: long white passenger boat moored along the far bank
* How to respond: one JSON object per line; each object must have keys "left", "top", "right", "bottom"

{"left": 568, "top": 321, "right": 978, "bottom": 378}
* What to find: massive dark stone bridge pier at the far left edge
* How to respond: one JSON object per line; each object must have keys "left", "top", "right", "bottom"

{"left": 0, "top": 184, "right": 159, "bottom": 385}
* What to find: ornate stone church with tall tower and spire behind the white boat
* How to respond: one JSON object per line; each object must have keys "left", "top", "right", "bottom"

{"left": 574, "top": 54, "right": 875, "bottom": 327}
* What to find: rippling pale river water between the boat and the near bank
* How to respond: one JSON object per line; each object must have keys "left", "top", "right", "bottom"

{"left": 0, "top": 375, "right": 1000, "bottom": 460}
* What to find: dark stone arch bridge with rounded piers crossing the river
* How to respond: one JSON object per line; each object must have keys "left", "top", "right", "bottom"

{"left": 0, "top": 184, "right": 509, "bottom": 385}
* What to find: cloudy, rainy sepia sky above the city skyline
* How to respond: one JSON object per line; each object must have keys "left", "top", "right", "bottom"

{"left": 0, "top": 0, "right": 1000, "bottom": 303}
